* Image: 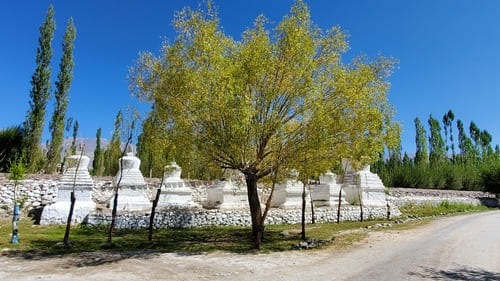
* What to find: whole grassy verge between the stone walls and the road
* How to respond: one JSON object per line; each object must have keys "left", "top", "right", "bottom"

{"left": 0, "top": 202, "right": 487, "bottom": 255}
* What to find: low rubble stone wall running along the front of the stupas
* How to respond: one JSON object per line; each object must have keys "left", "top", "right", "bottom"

{"left": 87, "top": 206, "right": 401, "bottom": 229}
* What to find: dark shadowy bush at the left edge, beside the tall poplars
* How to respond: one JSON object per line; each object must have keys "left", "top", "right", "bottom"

{"left": 0, "top": 126, "right": 24, "bottom": 173}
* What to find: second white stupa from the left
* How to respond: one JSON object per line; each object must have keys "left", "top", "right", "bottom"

{"left": 109, "top": 152, "right": 151, "bottom": 212}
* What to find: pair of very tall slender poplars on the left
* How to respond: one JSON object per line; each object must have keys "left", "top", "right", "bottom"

{"left": 23, "top": 5, "right": 78, "bottom": 173}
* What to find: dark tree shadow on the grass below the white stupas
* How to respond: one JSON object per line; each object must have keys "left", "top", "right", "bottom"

{"left": 3, "top": 226, "right": 300, "bottom": 268}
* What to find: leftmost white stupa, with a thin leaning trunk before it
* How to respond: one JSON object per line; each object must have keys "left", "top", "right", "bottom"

{"left": 40, "top": 150, "right": 96, "bottom": 225}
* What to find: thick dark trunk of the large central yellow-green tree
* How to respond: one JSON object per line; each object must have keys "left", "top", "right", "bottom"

{"left": 245, "top": 173, "right": 264, "bottom": 249}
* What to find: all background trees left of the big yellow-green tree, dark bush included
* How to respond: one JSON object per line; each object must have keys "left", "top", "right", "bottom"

{"left": 0, "top": 5, "right": 123, "bottom": 176}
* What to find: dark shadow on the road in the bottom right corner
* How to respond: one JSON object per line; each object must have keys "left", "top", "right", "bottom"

{"left": 409, "top": 266, "right": 500, "bottom": 281}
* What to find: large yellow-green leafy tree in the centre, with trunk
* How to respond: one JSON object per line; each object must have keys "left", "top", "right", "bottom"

{"left": 130, "top": 1, "right": 399, "bottom": 248}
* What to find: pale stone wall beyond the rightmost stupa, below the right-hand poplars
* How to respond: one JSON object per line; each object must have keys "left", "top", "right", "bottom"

{"left": 387, "top": 187, "right": 500, "bottom": 207}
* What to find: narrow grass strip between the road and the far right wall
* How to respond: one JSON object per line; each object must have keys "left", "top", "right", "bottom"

{"left": 399, "top": 201, "right": 489, "bottom": 217}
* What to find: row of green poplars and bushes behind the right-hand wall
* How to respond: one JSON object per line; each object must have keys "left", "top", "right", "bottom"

{"left": 373, "top": 110, "right": 500, "bottom": 193}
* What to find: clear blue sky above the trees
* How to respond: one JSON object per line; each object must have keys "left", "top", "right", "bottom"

{"left": 0, "top": 0, "right": 500, "bottom": 153}
